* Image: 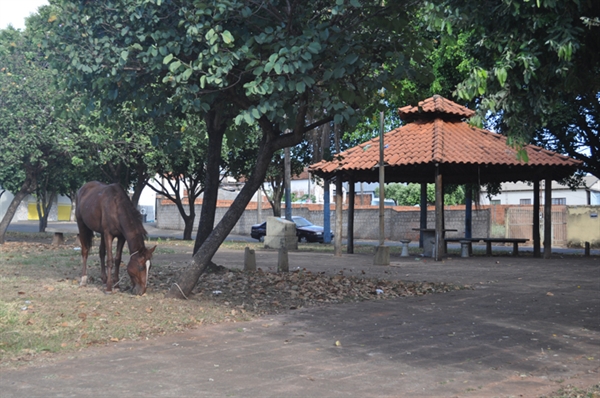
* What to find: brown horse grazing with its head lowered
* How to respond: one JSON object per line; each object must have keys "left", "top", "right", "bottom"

{"left": 75, "top": 181, "right": 156, "bottom": 296}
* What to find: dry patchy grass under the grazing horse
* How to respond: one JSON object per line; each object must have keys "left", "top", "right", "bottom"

{"left": 0, "top": 238, "right": 251, "bottom": 366}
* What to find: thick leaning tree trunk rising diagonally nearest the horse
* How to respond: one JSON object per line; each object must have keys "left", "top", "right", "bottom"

{"left": 167, "top": 137, "right": 274, "bottom": 298}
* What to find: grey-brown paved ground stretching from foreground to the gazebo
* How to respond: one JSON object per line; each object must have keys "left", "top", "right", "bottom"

{"left": 0, "top": 222, "right": 600, "bottom": 398}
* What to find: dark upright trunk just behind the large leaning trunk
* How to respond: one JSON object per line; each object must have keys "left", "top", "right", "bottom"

{"left": 194, "top": 111, "right": 227, "bottom": 254}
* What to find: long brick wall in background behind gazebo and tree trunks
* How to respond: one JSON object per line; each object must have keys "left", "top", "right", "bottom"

{"left": 156, "top": 200, "right": 491, "bottom": 241}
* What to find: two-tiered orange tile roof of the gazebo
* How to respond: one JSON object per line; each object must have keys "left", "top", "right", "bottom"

{"left": 310, "top": 96, "right": 581, "bottom": 183}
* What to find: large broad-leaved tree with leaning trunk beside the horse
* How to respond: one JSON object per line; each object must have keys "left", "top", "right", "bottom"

{"left": 48, "top": 0, "right": 432, "bottom": 297}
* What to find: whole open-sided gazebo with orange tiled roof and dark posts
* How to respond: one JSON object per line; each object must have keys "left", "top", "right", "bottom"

{"left": 310, "top": 95, "right": 581, "bottom": 260}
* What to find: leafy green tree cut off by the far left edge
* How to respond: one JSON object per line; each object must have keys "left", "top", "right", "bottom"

{"left": 0, "top": 28, "right": 74, "bottom": 244}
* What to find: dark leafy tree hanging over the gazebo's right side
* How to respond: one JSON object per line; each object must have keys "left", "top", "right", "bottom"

{"left": 429, "top": 0, "right": 600, "bottom": 176}
